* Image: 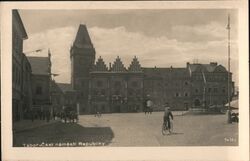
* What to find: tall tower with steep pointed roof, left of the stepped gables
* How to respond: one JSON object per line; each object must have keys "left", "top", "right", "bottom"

{"left": 70, "top": 24, "right": 95, "bottom": 114}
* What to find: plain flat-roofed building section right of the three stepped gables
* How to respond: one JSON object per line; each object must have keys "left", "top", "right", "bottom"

{"left": 143, "top": 67, "right": 192, "bottom": 110}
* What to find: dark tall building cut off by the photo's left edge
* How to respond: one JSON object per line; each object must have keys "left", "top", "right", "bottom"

{"left": 12, "top": 10, "right": 32, "bottom": 121}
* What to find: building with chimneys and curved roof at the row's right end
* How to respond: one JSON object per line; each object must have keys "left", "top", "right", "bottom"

{"left": 187, "top": 62, "right": 234, "bottom": 107}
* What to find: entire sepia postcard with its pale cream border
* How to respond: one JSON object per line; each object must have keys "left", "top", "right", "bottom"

{"left": 1, "top": 2, "right": 249, "bottom": 160}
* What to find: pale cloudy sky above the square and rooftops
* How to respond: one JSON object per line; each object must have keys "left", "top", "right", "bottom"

{"left": 19, "top": 9, "right": 238, "bottom": 85}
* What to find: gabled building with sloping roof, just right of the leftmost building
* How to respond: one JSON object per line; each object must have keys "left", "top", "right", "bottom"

{"left": 28, "top": 51, "right": 52, "bottom": 110}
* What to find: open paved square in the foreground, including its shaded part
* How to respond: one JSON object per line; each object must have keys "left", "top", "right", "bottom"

{"left": 14, "top": 112, "right": 238, "bottom": 146}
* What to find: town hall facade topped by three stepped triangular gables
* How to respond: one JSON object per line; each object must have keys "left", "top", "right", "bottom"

{"left": 88, "top": 57, "right": 143, "bottom": 113}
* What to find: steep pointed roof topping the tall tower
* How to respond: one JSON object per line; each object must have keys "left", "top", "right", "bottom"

{"left": 73, "top": 24, "right": 93, "bottom": 48}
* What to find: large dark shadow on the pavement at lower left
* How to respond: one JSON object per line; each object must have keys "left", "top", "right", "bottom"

{"left": 13, "top": 122, "right": 114, "bottom": 147}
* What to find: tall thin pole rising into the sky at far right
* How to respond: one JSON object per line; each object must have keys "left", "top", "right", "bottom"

{"left": 227, "top": 14, "right": 232, "bottom": 124}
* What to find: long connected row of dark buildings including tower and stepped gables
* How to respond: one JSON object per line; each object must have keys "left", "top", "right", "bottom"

{"left": 70, "top": 25, "right": 234, "bottom": 114}
